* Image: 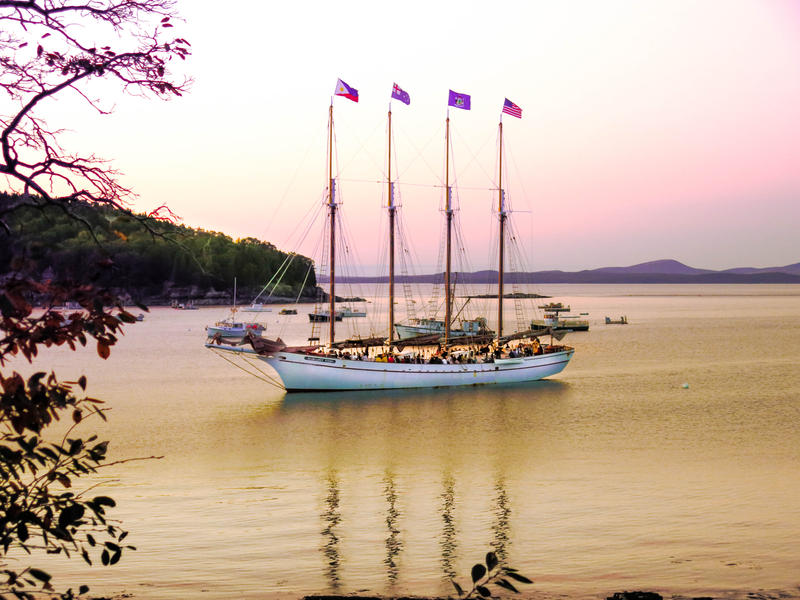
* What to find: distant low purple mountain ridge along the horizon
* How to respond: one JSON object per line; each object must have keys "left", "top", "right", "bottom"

{"left": 318, "top": 259, "right": 800, "bottom": 283}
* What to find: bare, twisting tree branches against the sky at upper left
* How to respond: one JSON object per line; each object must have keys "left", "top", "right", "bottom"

{"left": 0, "top": 0, "right": 191, "bottom": 230}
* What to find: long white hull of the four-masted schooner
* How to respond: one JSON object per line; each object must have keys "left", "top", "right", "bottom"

{"left": 206, "top": 346, "right": 574, "bottom": 392}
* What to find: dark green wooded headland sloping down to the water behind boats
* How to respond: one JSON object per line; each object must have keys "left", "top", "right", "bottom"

{"left": 0, "top": 193, "right": 320, "bottom": 306}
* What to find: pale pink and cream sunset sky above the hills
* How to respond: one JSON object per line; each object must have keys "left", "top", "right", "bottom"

{"left": 48, "top": 0, "right": 800, "bottom": 273}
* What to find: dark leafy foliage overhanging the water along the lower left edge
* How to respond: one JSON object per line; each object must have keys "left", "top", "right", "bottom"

{"left": 0, "top": 276, "right": 145, "bottom": 598}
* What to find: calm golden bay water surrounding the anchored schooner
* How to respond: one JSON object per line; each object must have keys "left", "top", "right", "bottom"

{"left": 18, "top": 285, "right": 800, "bottom": 599}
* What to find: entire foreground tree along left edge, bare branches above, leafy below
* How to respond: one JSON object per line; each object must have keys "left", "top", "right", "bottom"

{"left": 0, "top": 0, "right": 190, "bottom": 598}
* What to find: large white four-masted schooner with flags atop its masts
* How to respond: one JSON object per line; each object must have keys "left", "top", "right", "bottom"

{"left": 206, "top": 80, "right": 574, "bottom": 392}
